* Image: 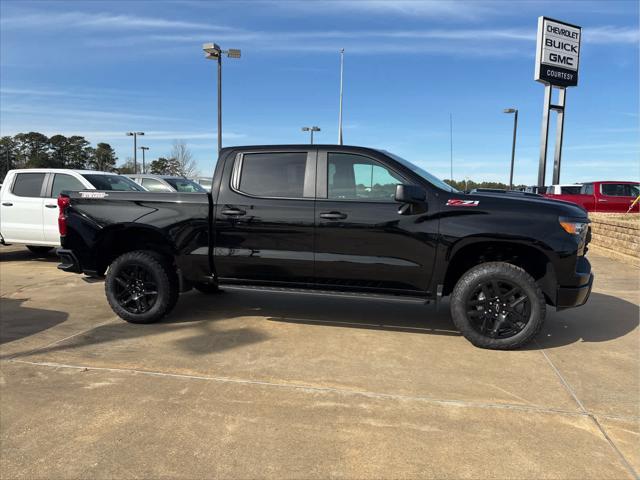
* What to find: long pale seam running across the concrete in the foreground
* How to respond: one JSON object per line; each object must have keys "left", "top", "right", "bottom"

{"left": 9, "top": 359, "right": 604, "bottom": 417}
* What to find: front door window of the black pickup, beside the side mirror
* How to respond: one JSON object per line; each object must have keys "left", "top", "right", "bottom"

{"left": 327, "top": 153, "right": 405, "bottom": 202}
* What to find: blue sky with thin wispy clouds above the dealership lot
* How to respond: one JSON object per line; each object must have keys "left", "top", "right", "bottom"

{"left": 0, "top": 0, "right": 640, "bottom": 184}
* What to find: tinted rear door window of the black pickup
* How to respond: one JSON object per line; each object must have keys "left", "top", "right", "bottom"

{"left": 238, "top": 152, "right": 307, "bottom": 198}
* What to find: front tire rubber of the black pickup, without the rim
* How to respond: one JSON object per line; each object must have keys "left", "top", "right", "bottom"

{"left": 450, "top": 262, "right": 546, "bottom": 350}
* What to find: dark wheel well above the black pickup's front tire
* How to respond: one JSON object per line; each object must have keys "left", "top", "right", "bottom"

{"left": 442, "top": 242, "right": 555, "bottom": 302}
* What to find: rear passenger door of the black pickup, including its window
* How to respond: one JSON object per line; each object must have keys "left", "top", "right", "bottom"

{"left": 215, "top": 151, "right": 316, "bottom": 283}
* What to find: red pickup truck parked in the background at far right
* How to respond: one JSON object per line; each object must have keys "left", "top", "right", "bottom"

{"left": 544, "top": 181, "right": 640, "bottom": 213}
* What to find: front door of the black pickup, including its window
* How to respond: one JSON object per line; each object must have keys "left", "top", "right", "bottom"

{"left": 315, "top": 151, "right": 438, "bottom": 292}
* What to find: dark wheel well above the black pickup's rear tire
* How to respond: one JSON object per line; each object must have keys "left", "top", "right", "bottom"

{"left": 95, "top": 227, "right": 174, "bottom": 274}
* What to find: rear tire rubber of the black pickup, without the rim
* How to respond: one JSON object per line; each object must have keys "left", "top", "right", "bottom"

{"left": 104, "top": 250, "right": 180, "bottom": 323}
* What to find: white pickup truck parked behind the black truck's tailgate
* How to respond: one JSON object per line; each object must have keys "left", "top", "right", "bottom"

{"left": 0, "top": 168, "right": 145, "bottom": 255}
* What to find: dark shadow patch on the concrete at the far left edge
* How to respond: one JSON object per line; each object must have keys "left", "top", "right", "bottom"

{"left": 0, "top": 298, "right": 69, "bottom": 344}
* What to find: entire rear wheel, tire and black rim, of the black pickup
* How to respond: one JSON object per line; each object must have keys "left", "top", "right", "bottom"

{"left": 105, "top": 250, "right": 179, "bottom": 323}
